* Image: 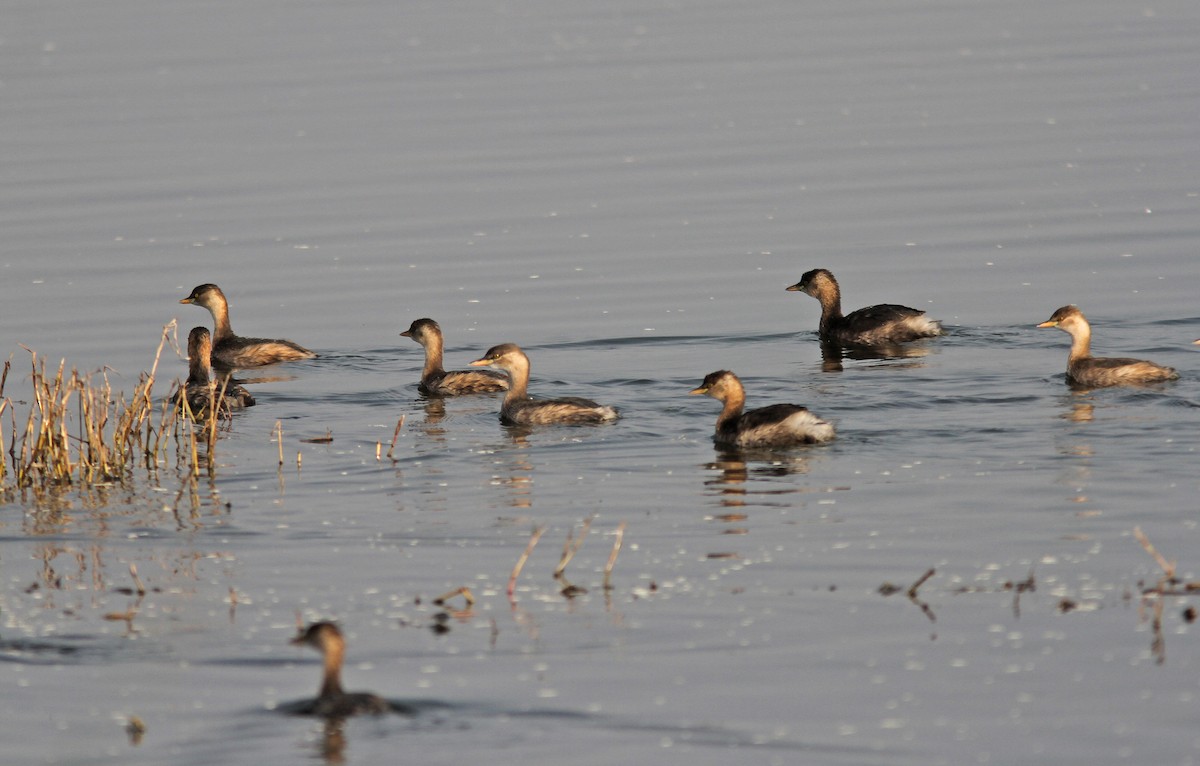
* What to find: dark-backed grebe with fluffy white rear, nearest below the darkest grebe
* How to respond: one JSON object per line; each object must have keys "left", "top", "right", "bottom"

{"left": 689, "top": 370, "right": 834, "bottom": 447}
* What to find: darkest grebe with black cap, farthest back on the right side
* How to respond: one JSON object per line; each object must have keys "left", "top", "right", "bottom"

{"left": 787, "top": 269, "right": 942, "bottom": 346}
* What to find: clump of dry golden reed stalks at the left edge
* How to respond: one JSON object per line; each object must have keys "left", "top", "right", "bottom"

{"left": 0, "top": 322, "right": 220, "bottom": 490}
